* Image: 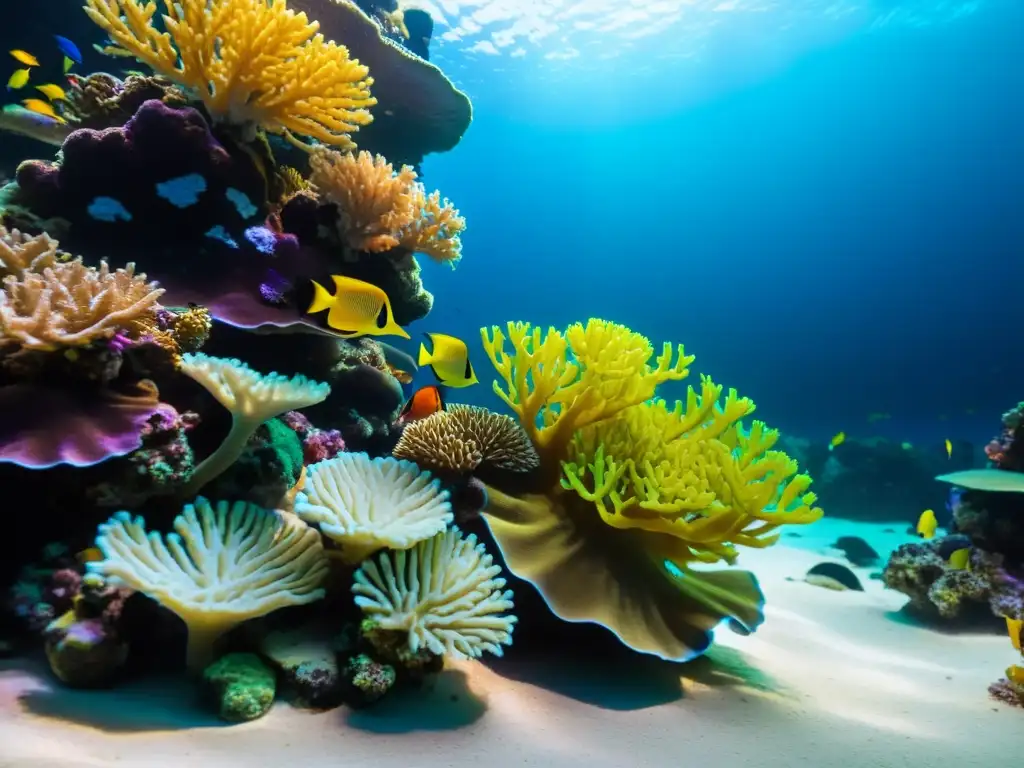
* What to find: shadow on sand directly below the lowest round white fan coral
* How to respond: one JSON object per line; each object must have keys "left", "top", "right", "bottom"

{"left": 341, "top": 669, "right": 487, "bottom": 733}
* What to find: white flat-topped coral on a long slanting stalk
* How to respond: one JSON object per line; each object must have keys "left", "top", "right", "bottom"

{"left": 179, "top": 352, "right": 331, "bottom": 497}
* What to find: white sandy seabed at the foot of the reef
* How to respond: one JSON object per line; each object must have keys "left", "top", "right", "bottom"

{"left": 0, "top": 520, "right": 1024, "bottom": 768}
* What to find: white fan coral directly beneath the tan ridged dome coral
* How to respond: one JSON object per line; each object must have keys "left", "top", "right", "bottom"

{"left": 295, "top": 454, "right": 453, "bottom": 565}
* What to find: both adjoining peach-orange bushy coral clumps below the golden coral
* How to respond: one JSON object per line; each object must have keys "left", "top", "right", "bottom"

{"left": 310, "top": 148, "right": 466, "bottom": 265}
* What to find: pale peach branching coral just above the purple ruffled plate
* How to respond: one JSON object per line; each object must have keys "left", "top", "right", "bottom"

{"left": 0, "top": 260, "right": 164, "bottom": 350}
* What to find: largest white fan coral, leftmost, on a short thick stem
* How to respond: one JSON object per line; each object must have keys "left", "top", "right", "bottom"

{"left": 87, "top": 498, "right": 328, "bottom": 671}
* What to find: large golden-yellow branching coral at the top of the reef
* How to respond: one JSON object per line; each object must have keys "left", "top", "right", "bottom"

{"left": 85, "top": 0, "right": 377, "bottom": 148}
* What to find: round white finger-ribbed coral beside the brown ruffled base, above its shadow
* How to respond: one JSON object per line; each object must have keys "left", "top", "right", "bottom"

{"left": 352, "top": 528, "right": 516, "bottom": 658}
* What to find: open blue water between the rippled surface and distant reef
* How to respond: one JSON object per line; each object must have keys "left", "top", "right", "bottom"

{"left": 419, "top": 3, "right": 1024, "bottom": 444}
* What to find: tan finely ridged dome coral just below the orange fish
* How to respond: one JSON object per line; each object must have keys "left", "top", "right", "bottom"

{"left": 392, "top": 404, "right": 540, "bottom": 472}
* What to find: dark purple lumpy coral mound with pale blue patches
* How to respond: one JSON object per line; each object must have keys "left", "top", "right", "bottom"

{"left": 6, "top": 99, "right": 269, "bottom": 247}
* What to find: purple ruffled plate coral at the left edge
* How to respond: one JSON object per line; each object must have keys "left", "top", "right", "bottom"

{"left": 0, "top": 382, "right": 178, "bottom": 469}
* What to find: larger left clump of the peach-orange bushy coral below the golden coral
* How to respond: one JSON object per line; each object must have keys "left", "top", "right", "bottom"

{"left": 309, "top": 150, "right": 416, "bottom": 253}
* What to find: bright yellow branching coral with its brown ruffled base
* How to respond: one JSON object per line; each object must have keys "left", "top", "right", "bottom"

{"left": 481, "top": 318, "right": 821, "bottom": 660}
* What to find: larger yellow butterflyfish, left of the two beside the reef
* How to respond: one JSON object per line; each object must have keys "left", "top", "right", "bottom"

{"left": 306, "top": 274, "right": 409, "bottom": 339}
